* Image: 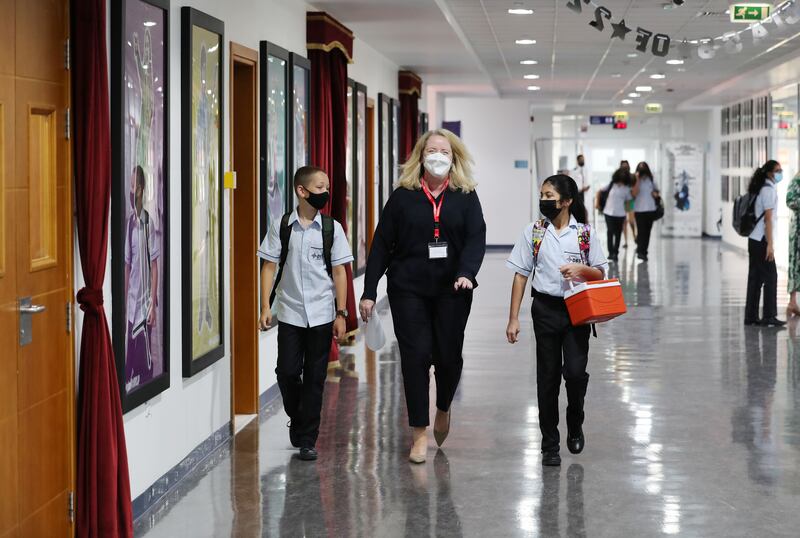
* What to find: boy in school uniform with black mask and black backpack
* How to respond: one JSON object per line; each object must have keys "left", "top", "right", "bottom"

{"left": 258, "top": 166, "right": 353, "bottom": 461}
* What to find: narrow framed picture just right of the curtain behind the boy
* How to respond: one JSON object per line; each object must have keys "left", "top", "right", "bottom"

{"left": 353, "top": 83, "right": 369, "bottom": 276}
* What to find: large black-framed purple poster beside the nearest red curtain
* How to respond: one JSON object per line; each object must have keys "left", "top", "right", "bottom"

{"left": 111, "top": 0, "right": 169, "bottom": 413}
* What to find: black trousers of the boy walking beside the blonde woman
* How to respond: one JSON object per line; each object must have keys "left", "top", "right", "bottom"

{"left": 275, "top": 323, "right": 333, "bottom": 447}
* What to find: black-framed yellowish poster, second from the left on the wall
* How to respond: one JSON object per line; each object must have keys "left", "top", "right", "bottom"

{"left": 181, "top": 7, "right": 225, "bottom": 377}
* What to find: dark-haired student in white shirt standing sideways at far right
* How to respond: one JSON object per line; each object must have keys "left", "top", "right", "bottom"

{"left": 744, "top": 161, "right": 786, "bottom": 327}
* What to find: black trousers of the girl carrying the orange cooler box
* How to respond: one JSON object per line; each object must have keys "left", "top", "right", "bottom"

{"left": 531, "top": 292, "right": 591, "bottom": 452}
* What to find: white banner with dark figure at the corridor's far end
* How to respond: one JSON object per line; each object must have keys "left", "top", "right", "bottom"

{"left": 661, "top": 142, "right": 705, "bottom": 237}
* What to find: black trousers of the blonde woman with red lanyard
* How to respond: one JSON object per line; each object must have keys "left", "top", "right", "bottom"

{"left": 389, "top": 291, "right": 472, "bottom": 428}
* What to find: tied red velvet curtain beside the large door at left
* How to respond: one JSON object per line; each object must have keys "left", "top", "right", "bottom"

{"left": 71, "top": 0, "right": 133, "bottom": 538}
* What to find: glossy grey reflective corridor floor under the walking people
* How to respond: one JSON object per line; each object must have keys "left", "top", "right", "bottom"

{"left": 136, "top": 240, "right": 800, "bottom": 537}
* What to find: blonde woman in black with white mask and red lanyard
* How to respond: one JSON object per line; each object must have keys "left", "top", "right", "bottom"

{"left": 359, "top": 129, "right": 486, "bottom": 463}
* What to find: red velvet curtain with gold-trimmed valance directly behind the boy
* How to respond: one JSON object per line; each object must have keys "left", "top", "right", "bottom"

{"left": 307, "top": 13, "right": 358, "bottom": 340}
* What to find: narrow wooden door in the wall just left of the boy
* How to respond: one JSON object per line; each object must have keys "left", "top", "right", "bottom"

{"left": 230, "top": 43, "right": 258, "bottom": 418}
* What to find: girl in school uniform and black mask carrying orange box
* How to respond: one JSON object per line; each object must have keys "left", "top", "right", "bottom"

{"left": 506, "top": 175, "right": 608, "bottom": 466}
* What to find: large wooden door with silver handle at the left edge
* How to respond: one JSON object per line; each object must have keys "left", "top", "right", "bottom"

{"left": 0, "top": 0, "right": 74, "bottom": 537}
